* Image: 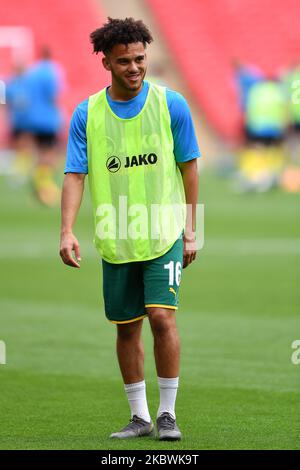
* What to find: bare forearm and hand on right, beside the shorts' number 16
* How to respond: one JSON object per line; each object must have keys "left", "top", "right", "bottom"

{"left": 177, "top": 158, "right": 199, "bottom": 268}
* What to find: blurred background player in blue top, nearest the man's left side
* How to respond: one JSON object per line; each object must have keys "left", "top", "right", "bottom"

{"left": 28, "top": 47, "right": 62, "bottom": 207}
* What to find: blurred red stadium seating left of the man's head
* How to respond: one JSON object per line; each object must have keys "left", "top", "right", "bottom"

{"left": 0, "top": 0, "right": 105, "bottom": 141}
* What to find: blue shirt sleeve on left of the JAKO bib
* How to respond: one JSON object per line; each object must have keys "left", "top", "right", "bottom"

{"left": 65, "top": 100, "right": 88, "bottom": 173}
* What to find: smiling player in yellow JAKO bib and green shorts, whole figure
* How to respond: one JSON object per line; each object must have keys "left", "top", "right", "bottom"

{"left": 60, "top": 18, "right": 200, "bottom": 440}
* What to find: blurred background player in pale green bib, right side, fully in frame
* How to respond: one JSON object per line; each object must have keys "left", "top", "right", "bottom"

{"left": 239, "top": 79, "right": 288, "bottom": 191}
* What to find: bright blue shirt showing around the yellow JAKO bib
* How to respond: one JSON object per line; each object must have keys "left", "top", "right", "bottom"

{"left": 65, "top": 81, "right": 201, "bottom": 173}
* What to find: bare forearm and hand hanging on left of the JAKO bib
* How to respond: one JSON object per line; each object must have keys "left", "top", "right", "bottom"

{"left": 59, "top": 173, "right": 86, "bottom": 268}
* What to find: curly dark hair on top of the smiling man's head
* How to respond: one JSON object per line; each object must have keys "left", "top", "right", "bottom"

{"left": 90, "top": 17, "right": 153, "bottom": 54}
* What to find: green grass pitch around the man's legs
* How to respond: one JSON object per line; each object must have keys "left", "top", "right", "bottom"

{"left": 0, "top": 173, "right": 300, "bottom": 450}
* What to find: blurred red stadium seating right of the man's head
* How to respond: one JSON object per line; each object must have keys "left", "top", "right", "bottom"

{"left": 147, "top": 0, "right": 300, "bottom": 137}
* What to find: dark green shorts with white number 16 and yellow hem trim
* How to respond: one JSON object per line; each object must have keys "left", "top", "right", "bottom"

{"left": 102, "top": 236, "right": 183, "bottom": 323}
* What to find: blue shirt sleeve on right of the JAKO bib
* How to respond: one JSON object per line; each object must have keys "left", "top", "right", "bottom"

{"left": 166, "top": 89, "right": 201, "bottom": 162}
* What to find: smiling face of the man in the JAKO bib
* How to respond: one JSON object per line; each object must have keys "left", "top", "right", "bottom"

{"left": 102, "top": 42, "right": 147, "bottom": 91}
